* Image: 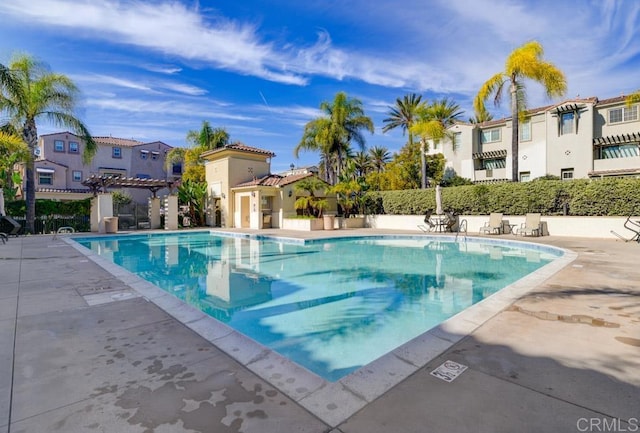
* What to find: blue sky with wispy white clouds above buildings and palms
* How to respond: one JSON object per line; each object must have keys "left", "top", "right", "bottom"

{"left": 0, "top": 0, "right": 640, "bottom": 172}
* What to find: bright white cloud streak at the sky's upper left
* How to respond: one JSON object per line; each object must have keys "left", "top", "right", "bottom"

{"left": 0, "top": 0, "right": 306, "bottom": 84}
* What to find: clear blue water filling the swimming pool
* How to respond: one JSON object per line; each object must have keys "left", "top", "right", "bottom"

{"left": 75, "top": 232, "right": 562, "bottom": 381}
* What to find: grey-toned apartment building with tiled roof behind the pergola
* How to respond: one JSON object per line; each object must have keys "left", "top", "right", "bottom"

{"left": 35, "top": 132, "right": 182, "bottom": 203}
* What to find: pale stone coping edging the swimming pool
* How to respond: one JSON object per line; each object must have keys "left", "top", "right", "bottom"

{"left": 62, "top": 229, "right": 578, "bottom": 427}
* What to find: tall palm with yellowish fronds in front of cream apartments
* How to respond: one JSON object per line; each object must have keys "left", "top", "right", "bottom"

{"left": 473, "top": 41, "right": 567, "bottom": 182}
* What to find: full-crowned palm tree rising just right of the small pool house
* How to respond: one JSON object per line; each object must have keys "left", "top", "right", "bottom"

{"left": 293, "top": 92, "right": 374, "bottom": 184}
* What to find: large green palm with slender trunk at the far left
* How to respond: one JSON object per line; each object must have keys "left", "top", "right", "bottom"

{"left": 0, "top": 54, "right": 97, "bottom": 233}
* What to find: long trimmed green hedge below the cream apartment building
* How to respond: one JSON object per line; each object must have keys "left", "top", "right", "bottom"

{"left": 365, "top": 178, "right": 640, "bottom": 216}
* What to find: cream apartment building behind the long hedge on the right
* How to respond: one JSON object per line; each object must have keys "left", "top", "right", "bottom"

{"left": 428, "top": 96, "right": 640, "bottom": 183}
